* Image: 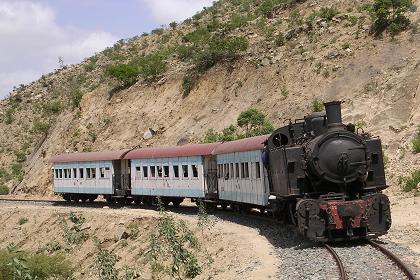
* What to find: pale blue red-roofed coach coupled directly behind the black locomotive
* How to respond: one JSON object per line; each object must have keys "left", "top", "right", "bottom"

{"left": 212, "top": 135, "right": 270, "bottom": 208}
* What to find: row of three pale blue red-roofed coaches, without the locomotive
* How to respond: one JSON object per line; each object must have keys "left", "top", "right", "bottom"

{"left": 51, "top": 136, "right": 269, "bottom": 210}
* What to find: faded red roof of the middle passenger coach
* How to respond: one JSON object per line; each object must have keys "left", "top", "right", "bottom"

{"left": 124, "top": 143, "right": 220, "bottom": 159}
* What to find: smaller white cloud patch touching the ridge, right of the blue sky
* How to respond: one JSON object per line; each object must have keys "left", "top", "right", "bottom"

{"left": 143, "top": 0, "right": 213, "bottom": 24}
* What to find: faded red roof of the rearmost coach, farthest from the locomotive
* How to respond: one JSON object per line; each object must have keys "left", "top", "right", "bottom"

{"left": 50, "top": 149, "right": 130, "bottom": 163}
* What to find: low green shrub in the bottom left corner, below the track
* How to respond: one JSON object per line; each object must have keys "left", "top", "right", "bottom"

{"left": 0, "top": 246, "right": 74, "bottom": 280}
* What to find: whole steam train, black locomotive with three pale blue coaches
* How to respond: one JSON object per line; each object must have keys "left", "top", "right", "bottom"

{"left": 50, "top": 101, "right": 391, "bottom": 242}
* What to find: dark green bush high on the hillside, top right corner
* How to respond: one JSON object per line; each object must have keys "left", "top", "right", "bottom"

{"left": 369, "top": 0, "right": 413, "bottom": 36}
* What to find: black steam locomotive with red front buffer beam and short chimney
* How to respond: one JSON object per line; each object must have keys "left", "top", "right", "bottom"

{"left": 266, "top": 101, "right": 391, "bottom": 241}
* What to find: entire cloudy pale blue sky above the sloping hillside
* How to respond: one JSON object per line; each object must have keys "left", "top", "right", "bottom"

{"left": 0, "top": 0, "right": 213, "bottom": 99}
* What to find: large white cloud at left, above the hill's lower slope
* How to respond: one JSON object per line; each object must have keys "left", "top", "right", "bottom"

{"left": 0, "top": 0, "right": 117, "bottom": 98}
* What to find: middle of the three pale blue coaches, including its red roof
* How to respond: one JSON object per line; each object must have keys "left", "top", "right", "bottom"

{"left": 124, "top": 143, "right": 218, "bottom": 205}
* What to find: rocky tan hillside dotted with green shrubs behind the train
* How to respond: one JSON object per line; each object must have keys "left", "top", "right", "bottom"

{"left": 0, "top": 0, "right": 420, "bottom": 195}
